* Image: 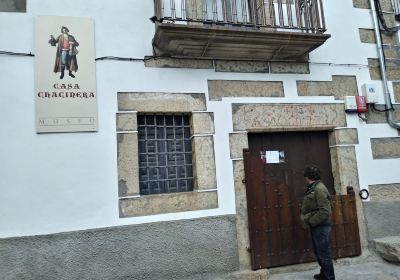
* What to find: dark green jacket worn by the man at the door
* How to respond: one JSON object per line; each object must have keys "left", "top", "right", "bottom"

{"left": 301, "top": 181, "right": 332, "bottom": 227}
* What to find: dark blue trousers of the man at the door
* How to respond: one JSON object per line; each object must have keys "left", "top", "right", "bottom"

{"left": 311, "top": 224, "right": 335, "bottom": 280}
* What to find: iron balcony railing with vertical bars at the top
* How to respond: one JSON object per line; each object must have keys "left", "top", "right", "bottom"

{"left": 153, "top": 0, "right": 326, "bottom": 33}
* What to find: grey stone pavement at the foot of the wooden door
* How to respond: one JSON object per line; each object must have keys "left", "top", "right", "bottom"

{"left": 268, "top": 255, "right": 400, "bottom": 280}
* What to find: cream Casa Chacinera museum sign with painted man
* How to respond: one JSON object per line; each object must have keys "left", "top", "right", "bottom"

{"left": 35, "top": 16, "right": 97, "bottom": 133}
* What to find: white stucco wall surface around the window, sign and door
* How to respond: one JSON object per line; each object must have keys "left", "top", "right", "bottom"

{"left": 0, "top": 0, "right": 400, "bottom": 237}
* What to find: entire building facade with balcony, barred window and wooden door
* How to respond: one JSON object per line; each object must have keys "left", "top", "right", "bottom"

{"left": 0, "top": 0, "right": 400, "bottom": 279}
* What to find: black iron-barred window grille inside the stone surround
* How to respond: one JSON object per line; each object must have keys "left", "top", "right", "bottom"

{"left": 138, "top": 115, "right": 193, "bottom": 195}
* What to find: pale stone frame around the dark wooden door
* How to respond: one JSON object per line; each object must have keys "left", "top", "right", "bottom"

{"left": 229, "top": 103, "right": 368, "bottom": 270}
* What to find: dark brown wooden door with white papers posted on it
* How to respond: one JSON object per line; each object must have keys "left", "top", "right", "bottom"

{"left": 244, "top": 132, "right": 359, "bottom": 269}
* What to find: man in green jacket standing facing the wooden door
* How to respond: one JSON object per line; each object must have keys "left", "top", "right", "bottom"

{"left": 301, "top": 165, "right": 335, "bottom": 280}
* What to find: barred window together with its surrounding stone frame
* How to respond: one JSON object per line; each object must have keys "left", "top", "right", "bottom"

{"left": 116, "top": 92, "right": 218, "bottom": 218}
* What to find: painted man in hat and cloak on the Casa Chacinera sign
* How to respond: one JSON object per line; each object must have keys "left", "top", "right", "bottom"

{"left": 49, "top": 26, "right": 79, "bottom": 79}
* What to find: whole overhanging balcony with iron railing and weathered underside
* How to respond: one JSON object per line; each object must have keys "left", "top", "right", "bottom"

{"left": 151, "top": 0, "right": 330, "bottom": 60}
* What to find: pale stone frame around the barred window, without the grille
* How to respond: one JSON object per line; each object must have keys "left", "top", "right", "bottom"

{"left": 116, "top": 92, "right": 218, "bottom": 218}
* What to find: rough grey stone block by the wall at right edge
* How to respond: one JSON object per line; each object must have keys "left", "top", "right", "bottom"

{"left": 373, "top": 236, "right": 400, "bottom": 264}
